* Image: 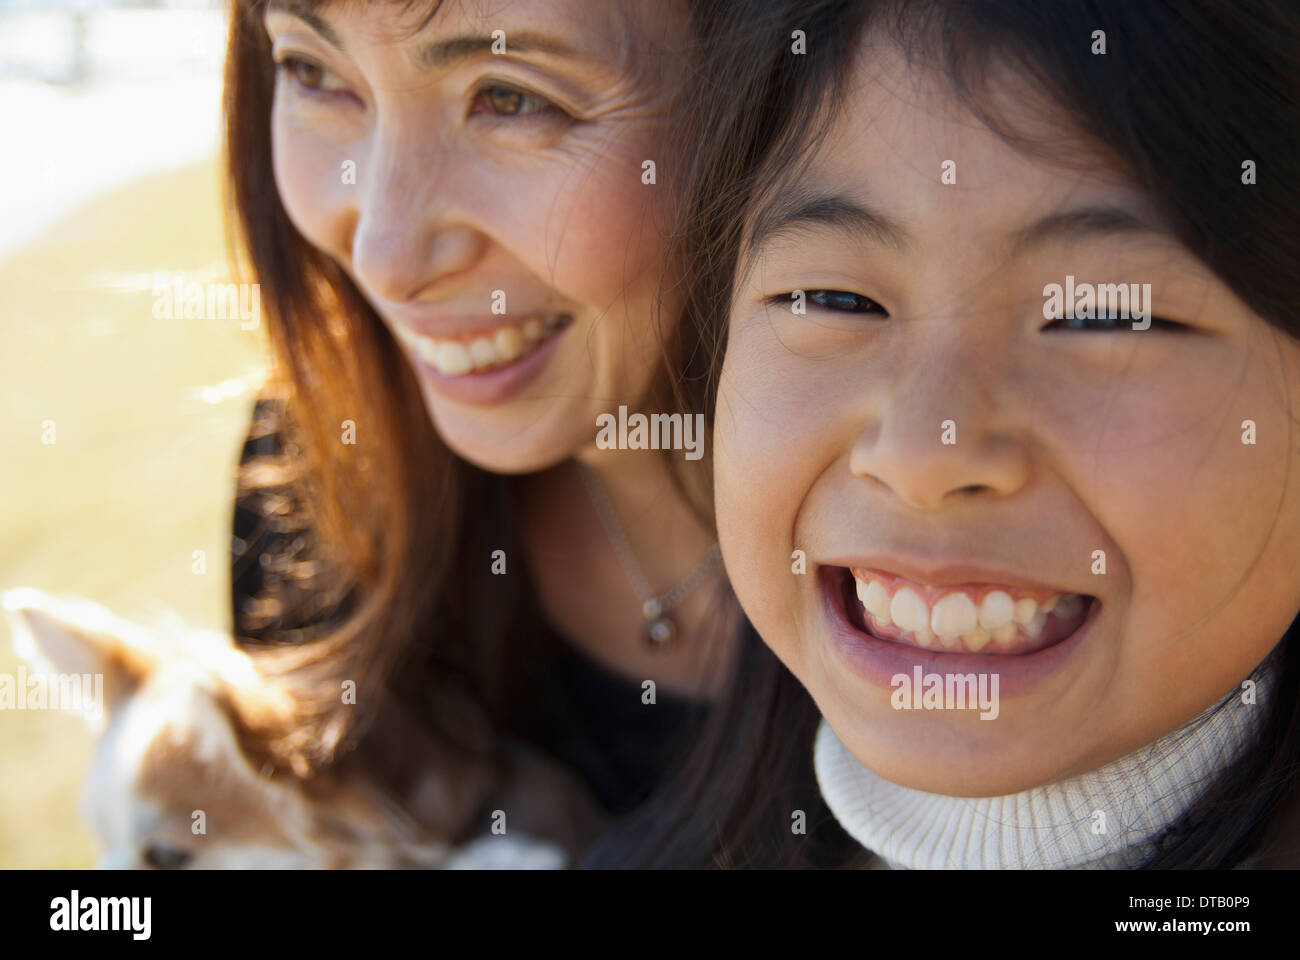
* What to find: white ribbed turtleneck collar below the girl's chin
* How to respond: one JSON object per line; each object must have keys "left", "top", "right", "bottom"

{"left": 814, "top": 675, "right": 1269, "bottom": 869}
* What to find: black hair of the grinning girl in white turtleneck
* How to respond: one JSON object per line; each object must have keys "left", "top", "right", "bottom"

{"left": 592, "top": 0, "right": 1300, "bottom": 868}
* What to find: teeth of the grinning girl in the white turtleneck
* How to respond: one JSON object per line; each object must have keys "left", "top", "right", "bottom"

{"left": 850, "top": 570, "right": 1088, "bottom": 653}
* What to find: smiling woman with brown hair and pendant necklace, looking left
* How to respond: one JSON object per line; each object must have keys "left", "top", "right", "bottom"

{"left": 218, "top": 0, "right": 735, "bottom": 858}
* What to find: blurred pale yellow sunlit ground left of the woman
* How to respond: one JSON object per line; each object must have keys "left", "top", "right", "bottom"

{"left": 0, "top": 157, "right": 264, "bottom": 868}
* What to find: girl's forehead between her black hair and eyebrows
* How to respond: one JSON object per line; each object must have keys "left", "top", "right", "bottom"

{"left": 746, "top": 42, "right": 1160, "bottom": 251}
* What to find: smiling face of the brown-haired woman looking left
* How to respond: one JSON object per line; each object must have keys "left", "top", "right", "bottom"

{"left": 265, "top": 0, "right": 685, "bottom": 472}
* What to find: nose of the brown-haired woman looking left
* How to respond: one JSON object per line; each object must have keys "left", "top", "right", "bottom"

{"left": 352, "top": 127, "right": 489, "bottom": 303}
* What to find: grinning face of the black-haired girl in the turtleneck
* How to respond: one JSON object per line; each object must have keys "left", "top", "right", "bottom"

{"left": 715, "top": 41, "right": 1300, "bottom": 796}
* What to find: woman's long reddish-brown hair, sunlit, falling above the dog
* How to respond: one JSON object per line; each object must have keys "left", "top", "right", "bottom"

{"left": 225, "top": 0, "right": 711, "bottom": 777}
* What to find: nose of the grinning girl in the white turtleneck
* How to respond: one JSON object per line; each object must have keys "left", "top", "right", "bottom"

{"left": 849, "top": 349, "right": 1030, "bottom": 510}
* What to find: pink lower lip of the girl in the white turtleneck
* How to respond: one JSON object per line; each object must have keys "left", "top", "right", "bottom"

{"left": 816, "top": 566, "right": 1101, "bottom": 696}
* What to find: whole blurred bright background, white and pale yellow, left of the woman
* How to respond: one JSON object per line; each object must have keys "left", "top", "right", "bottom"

{"left": 0, "top": 0, "right": 265, "bottom": 869}
